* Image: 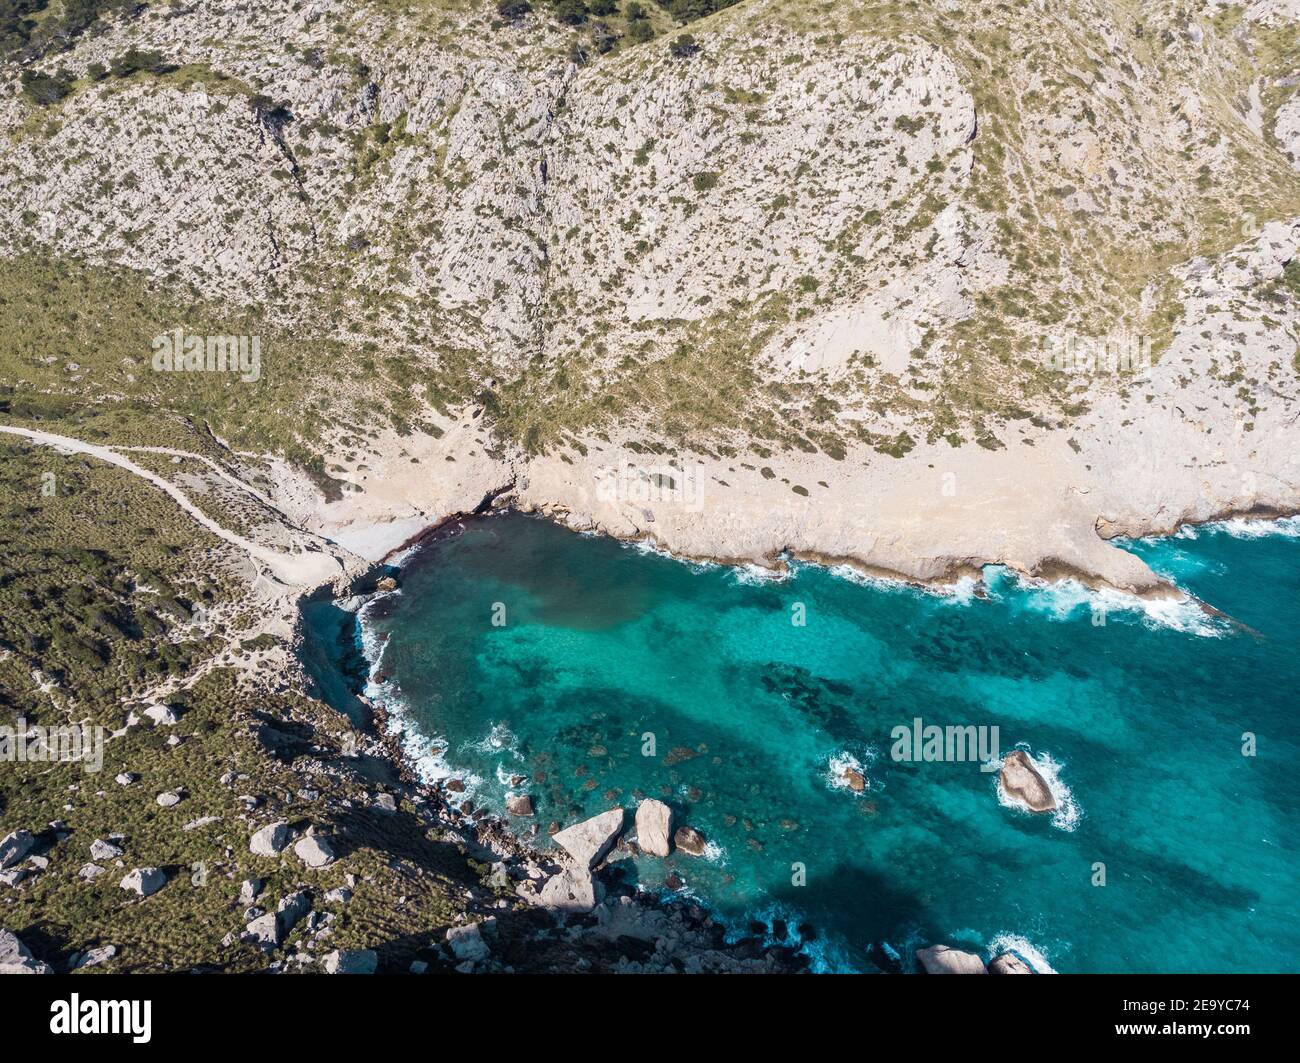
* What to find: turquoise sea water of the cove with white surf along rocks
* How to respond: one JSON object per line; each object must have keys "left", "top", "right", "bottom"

{"left": 317, "top": 516, "right": 1300, "bottom": 972}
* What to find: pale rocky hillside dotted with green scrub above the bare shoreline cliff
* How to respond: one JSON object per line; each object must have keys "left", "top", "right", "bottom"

{"left": 0, "top": 0, "right": 1300, "bottom": 455}
